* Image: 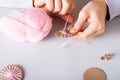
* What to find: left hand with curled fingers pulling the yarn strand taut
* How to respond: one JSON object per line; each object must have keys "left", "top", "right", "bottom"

{"left": 34, "top": 0, "right": 75, "bottom": 22}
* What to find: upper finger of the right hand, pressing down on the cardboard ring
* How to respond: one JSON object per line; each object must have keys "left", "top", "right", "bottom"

{"left": 70, "top": 12, "right": 88, "bottom": 33}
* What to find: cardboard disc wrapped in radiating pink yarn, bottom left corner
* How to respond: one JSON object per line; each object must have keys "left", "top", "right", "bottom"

{"left": 0, "top": 65, "right": 23, "bottom": 80}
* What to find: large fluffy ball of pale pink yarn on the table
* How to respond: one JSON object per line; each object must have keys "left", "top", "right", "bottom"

{"left": 0, "top": 8, "right": 52, "bottom": 42}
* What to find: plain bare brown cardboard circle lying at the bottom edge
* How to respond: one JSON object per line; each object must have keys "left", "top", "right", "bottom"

{"left": 83, "top": 67, "right": 107, "bottom": 80}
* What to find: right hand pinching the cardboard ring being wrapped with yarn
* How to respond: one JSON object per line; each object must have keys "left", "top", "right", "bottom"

{"left": 69, "top": 0, "right": 107, "bottom": 40}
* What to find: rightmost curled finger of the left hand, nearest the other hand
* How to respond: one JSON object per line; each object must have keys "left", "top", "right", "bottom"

{"left": 59, "top": 0, "right": 72, "bottom": 15}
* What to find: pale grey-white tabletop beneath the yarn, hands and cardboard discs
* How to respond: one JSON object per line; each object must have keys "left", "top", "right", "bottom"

{"left": 0, "top": 0, "right": 120, "bottom": 80}
